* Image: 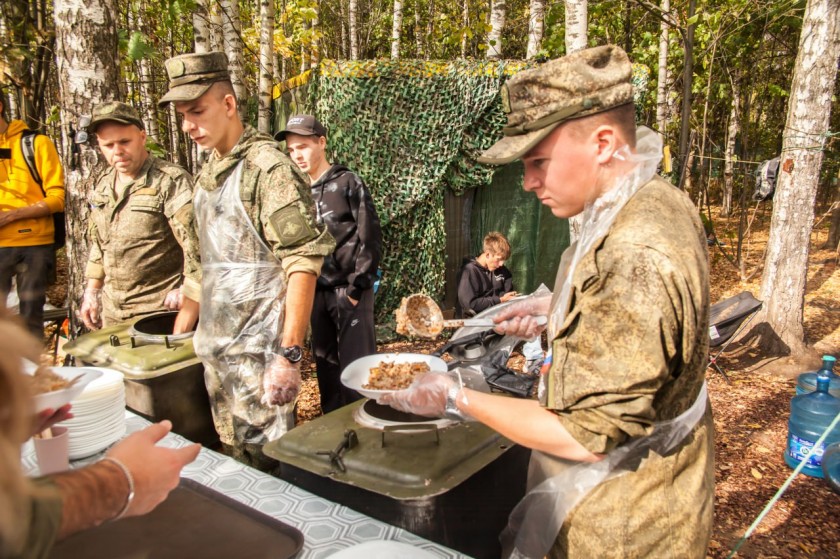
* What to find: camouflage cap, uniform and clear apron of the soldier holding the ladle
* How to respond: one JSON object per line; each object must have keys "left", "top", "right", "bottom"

{"left": 479, "top": 45, "right": 714, "bottom": 559}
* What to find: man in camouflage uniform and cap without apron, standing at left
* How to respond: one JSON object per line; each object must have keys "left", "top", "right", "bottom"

{"left": 81, "top": 102, "right": 201, "bottom": 334}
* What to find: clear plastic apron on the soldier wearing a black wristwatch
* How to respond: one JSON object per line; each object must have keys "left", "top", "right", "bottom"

{"left": 193, "top": 162, "right": 291, "bottom": 444}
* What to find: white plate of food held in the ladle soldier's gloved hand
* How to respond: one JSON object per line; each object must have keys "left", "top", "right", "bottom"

{"left": 341, "top": 353, "right": 447, "bottom": 400}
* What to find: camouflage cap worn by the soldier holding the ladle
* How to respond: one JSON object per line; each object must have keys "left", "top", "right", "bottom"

{"left": 478, "top": 45, "right": 633, "bottom": 165}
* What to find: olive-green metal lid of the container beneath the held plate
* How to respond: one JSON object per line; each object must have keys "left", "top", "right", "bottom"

{"left": 263, "top": 400, "right": 514, "bottom": 500}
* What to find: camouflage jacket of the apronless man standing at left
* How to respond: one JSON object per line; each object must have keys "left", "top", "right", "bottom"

{"left": 85, "top": 154, "right": 201, "bottom": 326}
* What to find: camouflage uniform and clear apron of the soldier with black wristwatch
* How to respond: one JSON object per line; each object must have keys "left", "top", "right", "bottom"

{"left": 195, "top": 127, "right": 335, "bottom": 469}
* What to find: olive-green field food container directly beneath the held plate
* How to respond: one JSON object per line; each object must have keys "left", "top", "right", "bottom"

{"left": 264, "top": 400, "right": 530, "bottom": 558}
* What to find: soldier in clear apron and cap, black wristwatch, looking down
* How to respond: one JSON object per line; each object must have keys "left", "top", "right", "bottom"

{"left": 160, "top": 52, "right": 335, "bottom": 471}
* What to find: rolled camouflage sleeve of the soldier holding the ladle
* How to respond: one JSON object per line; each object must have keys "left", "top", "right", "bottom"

{"left": 546, "top": 246, "right": 696, "bottom": 453}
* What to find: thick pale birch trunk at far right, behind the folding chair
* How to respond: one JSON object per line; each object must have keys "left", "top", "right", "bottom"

{"left": 761, "top": 0, "right": 840, "bottom": 355}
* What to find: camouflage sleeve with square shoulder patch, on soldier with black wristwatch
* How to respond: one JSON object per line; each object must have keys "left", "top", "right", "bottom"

{"left": 249, "top": 148, "right": 335, "bottom": 261}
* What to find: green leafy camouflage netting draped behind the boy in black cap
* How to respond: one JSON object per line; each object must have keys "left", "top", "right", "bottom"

{"left": 275, "top": 60, "right": 526, "bottom": 316}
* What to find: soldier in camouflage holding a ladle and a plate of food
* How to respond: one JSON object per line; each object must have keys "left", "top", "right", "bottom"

{"left": 382, "top": 45, "right": 714, "bottom": 559}
